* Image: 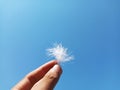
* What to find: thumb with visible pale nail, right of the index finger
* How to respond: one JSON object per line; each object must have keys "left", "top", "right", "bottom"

{"left": 31, "top": 64, "right": 62, "bottom": 90}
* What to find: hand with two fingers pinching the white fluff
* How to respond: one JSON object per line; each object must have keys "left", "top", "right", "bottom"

{"left": 12, "top": 60, "right": 62, "bottom": 90}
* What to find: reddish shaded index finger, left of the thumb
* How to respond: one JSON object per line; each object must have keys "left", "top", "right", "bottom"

{"left": 12, "top": 60, "right": 57, "bottom": 90}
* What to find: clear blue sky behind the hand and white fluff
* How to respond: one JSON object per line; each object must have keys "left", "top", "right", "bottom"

{"left": 0, "top": 0, "right": 120, "bottom": 90}
